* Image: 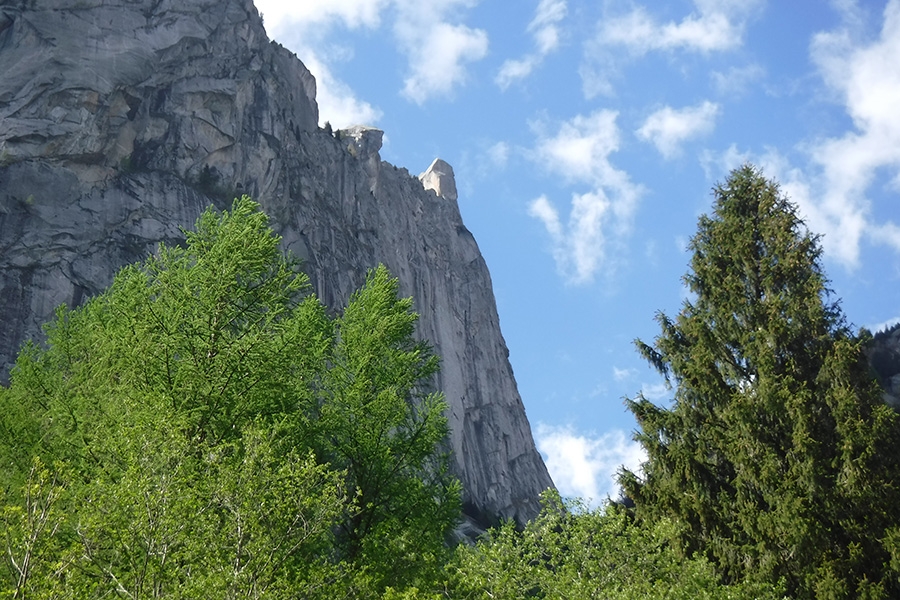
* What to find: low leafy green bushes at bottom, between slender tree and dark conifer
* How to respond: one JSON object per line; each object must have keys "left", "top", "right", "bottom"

{"left": 447, "top": 492, "right": 780, "bottom": 600}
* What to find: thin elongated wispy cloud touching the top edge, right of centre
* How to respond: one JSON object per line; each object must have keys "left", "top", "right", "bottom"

{"left": 581, "top": 0, "right": 764, "bottom": 97}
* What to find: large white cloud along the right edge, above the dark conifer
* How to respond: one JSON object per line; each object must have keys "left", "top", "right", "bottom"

{"left": 707, "top": 0, "right": 900, "bottom": 270}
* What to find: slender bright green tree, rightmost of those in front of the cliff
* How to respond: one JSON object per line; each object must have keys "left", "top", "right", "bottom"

{"left": 319, "top": 266, "right": 460, "bottom": 586}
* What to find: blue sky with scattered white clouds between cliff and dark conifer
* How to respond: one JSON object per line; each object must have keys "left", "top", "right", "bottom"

{"left": 256, "top": 0, "right": 900, "bottom": 500}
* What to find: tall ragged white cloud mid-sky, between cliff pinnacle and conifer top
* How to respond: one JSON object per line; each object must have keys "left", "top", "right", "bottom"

{"left": 529, "top": 110, "right": 641, "bottom": 283}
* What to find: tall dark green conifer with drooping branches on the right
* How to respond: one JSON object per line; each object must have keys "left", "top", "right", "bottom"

{"left": 621, "top": 167, "right": 900, "bottom": 598}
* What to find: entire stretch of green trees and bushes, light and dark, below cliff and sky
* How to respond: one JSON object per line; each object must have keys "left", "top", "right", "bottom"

{"left": 0, "top": 167, "right": 900, "bottom": 600}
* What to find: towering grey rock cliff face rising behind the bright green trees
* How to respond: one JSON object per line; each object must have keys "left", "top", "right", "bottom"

{"left": 0, "top": 0, "right": 552, "bottom": 522}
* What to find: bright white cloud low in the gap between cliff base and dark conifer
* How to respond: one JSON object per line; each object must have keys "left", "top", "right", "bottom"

{"left": 536, "top": 423, "right": 646, "bottom": 505}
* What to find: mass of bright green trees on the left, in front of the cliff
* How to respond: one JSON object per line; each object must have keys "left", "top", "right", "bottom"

{"left": 0, "top": 197, "right": 459, "bottom": 599}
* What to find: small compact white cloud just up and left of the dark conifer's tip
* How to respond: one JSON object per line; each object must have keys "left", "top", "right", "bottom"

{"left": 636, "top": 102, "right": 721, "bottom": 159}
